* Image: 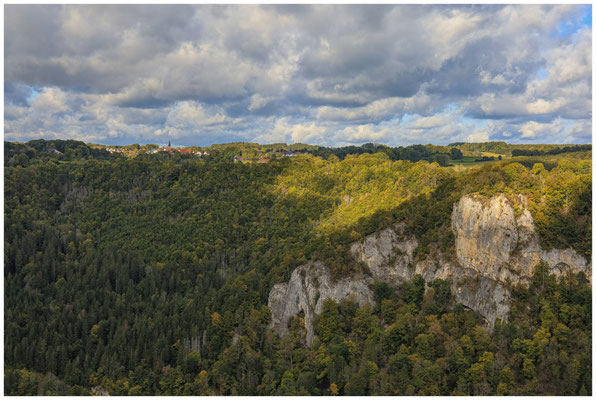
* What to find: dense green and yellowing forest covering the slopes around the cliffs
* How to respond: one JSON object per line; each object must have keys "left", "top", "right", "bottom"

{"left": 4, "top": 140, "right": 592, "bottom": 395}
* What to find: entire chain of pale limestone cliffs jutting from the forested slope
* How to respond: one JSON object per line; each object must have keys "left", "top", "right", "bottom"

{"left": 269, "top": 195, "right": 591, "bottom": 344}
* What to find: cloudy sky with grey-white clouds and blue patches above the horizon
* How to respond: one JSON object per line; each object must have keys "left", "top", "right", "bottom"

{"left": 4, "top": 5, "right": 592, "bottom": 146}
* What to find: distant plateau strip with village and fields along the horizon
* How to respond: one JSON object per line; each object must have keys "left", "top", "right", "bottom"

{"left": 4, "top": 139, "right": 592, "bottom": 166}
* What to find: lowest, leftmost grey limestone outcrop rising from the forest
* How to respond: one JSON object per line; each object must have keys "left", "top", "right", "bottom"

{"left": 267, "top": 262, "right": 374, "bottom": 344}
